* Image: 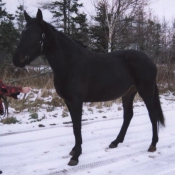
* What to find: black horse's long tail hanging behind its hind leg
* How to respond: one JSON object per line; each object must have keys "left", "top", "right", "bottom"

{"left": 154, "top": 85, "right": 165, "bottom": 126}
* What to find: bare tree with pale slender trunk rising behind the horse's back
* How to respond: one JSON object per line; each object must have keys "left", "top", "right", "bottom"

{"left": 93, "top": 0, "right": 149, "bottom": 52}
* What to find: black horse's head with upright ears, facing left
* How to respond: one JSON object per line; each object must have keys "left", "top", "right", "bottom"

{"left": 13, "top": 9, "right": 45, "bottom": 67}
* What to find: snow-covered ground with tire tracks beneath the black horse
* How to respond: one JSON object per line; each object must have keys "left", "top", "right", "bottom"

{"left": 0, "top": 93, "right": 175, "bottom": 175}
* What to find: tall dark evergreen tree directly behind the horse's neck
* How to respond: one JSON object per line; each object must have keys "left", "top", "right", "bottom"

{"left": 42, "top": 0, "right": 88, "bottom": 42}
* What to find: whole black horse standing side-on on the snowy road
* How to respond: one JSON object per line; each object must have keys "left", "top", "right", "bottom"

{"left": 13, "top": 9, "right": 164, "bottom": 166}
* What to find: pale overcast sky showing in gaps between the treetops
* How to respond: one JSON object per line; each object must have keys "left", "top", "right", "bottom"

{"left": 2, "top": 0, "right": 175, "bottom": 21}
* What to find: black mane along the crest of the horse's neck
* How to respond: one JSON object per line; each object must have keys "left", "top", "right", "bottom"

{"left": 44, "top": 21, "right": 87, "bottom": 48}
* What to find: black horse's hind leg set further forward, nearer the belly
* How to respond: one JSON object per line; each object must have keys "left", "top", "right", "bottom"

{"left": 109, "top": 86, "right": 137, "bottom": 148}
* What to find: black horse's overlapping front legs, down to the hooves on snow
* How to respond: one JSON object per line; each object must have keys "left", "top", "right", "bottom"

{"left": 66, "top": 100, "right": 83, "bottom": 166}
